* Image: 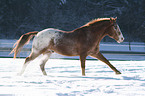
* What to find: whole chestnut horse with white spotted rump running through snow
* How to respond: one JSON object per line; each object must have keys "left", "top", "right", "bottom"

{"left": 11, "top": 17, "right": 124, "bottom": 76}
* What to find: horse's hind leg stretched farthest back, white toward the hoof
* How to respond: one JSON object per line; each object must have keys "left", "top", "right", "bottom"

{"left": 18, "top": 51, "right": 40, "bottom": 75}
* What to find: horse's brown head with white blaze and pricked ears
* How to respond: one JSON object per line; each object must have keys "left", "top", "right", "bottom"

{"left": 106, "top": 17, "right": 124, "bottom": 43}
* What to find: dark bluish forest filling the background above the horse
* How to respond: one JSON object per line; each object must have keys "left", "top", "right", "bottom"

{"left": 0, "top": 0, "right": 145, "bottom": 42}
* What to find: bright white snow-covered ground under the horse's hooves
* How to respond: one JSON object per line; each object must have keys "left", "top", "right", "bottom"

{"left": 0, "top": 58, "right": 145, "bottom": 96}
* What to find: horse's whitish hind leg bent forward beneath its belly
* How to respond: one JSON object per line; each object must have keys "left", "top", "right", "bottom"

{"left": 40, "top": 51, "right": 53, "bottom": 75}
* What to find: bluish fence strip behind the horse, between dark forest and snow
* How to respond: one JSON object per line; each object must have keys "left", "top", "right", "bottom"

{"left": 0, "top": 39, "right": 145, "bottom": 60}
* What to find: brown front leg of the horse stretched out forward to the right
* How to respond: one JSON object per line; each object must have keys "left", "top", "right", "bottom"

{"left": 90, "top": 52, "right": 121, "bottom": 74}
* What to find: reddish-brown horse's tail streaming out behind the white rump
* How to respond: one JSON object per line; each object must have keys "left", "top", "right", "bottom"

{"left": 10, "top": 31, "right": 38, "bottom": 58}
